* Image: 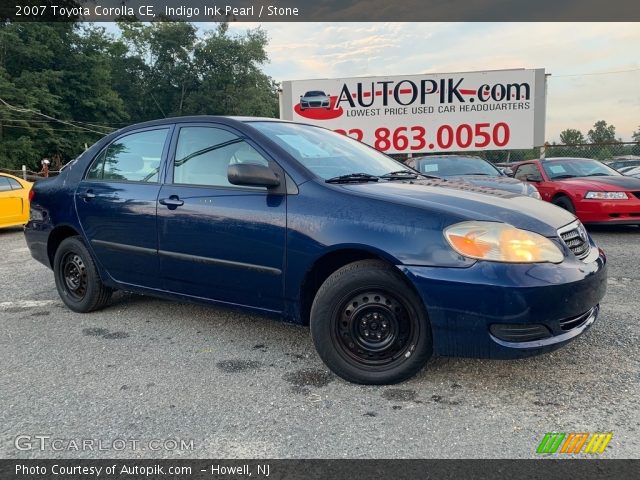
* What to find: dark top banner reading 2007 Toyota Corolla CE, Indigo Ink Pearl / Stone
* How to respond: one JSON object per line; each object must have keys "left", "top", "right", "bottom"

{"left": 0, "top": 0, "right": 640, "bottom": 22}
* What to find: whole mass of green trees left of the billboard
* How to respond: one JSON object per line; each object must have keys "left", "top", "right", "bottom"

{"left": 0, "top": 19, "right": 278, "bottom": 169}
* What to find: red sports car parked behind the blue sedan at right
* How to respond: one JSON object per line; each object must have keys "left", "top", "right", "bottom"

{"left": 512, "top": 158, "right": 640, "bottom": 225}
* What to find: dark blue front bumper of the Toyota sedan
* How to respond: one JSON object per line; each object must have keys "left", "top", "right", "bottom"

{"left": 399, "top": 246, "right": 607, "bottom": 359}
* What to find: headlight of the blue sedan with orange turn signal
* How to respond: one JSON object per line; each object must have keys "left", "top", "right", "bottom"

{"left": 444, "top": 221, "right": 564, "bottom": 263}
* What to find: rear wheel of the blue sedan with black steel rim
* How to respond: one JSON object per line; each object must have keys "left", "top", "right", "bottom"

{"left": 53, "top": 236, "right": 113, "bottom": 313}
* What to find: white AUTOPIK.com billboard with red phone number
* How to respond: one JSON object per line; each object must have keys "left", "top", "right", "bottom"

{"left": 280, "top": 69, "right": 546, "bottom": 153}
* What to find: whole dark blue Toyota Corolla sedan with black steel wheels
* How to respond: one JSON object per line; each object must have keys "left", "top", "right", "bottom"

{"left": 25, "top": 117, "right": 606, "bottom": 384}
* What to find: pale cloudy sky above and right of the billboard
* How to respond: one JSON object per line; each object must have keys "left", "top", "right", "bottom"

{"left": 224, "top": 22, "right": 640, "bottom": 142}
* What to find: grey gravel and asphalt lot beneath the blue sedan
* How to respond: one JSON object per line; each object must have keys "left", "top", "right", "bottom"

{"left": 0, "top": 227, "right": 640, "bottom": 458}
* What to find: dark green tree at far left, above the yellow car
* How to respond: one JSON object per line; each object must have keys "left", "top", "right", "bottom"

{"left": 0, "top": 22, "right": 126, "bottom": 170}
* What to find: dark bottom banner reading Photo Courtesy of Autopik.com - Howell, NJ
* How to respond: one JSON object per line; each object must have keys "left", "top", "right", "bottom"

{"left": 0, "top": 458, "right": 640, "bottom": 480}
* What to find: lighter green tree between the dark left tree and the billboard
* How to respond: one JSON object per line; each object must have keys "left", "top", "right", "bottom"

{"left": 112, "top": 22, "right": 278, "bottom": 121}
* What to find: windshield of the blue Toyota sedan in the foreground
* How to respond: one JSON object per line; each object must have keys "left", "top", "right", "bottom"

{"left": 251, "top": 122, "right": 409, "bottom": 180}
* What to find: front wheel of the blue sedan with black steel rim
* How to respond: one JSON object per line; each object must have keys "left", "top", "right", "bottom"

{"left": 311, "top": 260, "right": 433, "bottom": 385}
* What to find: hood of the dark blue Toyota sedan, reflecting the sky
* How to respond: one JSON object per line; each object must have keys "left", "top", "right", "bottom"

{"left": 340, "top": 179, "right": 576, "bottom": 237}
